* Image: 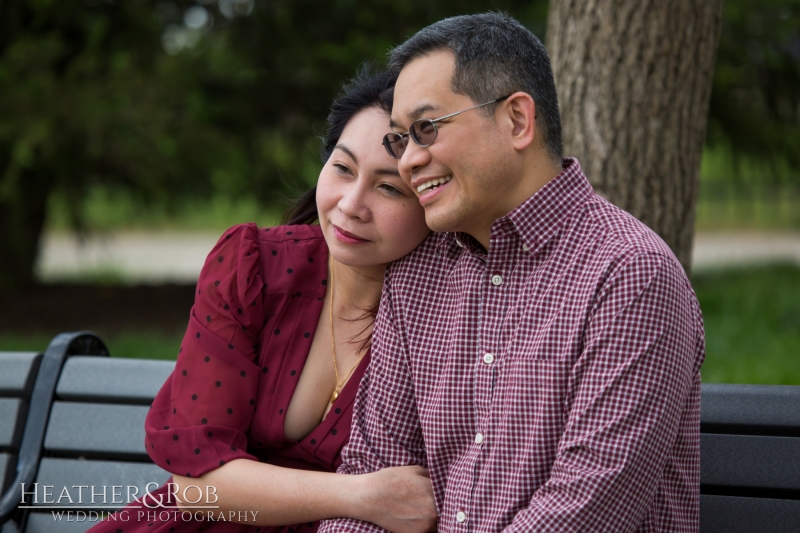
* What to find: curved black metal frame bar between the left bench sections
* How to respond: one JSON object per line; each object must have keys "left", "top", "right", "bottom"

{"left": 0, "top": 331, "right": 108, "bottom": 524}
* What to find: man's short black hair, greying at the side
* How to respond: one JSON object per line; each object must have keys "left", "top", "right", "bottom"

{"left": 389, "top": 13, "right": 563, "bottom": 163}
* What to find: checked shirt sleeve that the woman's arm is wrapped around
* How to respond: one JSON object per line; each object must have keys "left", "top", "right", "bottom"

{"left": 319, "top": 274, "right": 428, "bottom": 533}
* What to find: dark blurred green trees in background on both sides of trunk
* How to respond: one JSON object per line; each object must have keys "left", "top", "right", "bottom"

{"left": 0, "top": 0, "right": 800, "bottom": 288}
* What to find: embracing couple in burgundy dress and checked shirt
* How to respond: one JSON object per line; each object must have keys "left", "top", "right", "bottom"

{"left": 93, "top": 13, "right": 704, "bottom": 533}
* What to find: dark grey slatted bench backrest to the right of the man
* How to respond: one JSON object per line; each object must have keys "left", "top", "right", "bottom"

{"left": 700, "top": 384, "right": 800, "bottom": 533}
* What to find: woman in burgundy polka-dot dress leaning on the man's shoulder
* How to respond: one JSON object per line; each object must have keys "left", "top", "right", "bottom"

{"left": 87, "top": 70, "right": 435, "bottom": 533}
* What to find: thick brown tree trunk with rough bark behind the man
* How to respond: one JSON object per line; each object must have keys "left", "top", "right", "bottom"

{"left": 547, "top": 0, "right": 723, "bottom": 272}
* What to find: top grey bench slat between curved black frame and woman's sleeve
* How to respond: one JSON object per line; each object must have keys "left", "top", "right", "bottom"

{"left": 56, "top": 356, "right": 175, "bottom": 405}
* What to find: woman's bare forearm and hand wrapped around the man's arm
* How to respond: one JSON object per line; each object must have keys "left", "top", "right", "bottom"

{"left": 172, "top": 459, "right": 436, "bottom": 533}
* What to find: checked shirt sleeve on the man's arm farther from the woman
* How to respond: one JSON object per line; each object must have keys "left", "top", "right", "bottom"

{"left": 505, "top": 254, "right": 704, "bottom": 532}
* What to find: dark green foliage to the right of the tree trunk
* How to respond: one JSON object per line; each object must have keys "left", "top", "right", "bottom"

{"left": 708, "top": 0, "right": 800, "bottom": 184}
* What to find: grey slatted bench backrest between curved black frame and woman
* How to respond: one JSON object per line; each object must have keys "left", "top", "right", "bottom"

{"left": 25, "top": 356, "right": 175, "bottom": 533}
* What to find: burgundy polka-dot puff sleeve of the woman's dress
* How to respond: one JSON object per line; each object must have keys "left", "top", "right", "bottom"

{"left": 145, "top": 224, "right": 264, "bottom": 477}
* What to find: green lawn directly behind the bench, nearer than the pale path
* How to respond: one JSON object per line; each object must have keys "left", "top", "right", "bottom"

{"left": 0, "top": 265, "right": 800, "bottom": 385}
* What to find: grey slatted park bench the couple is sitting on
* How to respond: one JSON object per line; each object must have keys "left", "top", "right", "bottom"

{"left": 0, "top": 333, "right": 800, "bottom": 533}
